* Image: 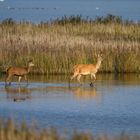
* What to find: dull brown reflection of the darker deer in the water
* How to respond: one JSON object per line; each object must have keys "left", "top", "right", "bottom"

{"left": 5, "top": 86, "right": 31, "bottom": 102}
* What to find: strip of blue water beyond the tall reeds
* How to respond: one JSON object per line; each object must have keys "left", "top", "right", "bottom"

{"left": 0, "top": 0, "right": 140, "bottom": 22}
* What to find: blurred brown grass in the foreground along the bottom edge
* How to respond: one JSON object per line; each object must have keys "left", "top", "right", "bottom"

{"left": 0, "top": 121, "right": 140, "bottom": 140}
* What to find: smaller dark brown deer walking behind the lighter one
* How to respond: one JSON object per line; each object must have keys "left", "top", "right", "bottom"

{"left": 5, "top": 60, "right": 34, "bottom": 85}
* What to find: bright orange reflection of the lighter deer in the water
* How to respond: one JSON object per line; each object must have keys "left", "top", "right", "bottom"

{"left": 73, "top": 87, "right": 101, "bottom": 101}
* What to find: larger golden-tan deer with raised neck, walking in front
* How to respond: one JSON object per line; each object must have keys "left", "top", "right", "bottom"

{"left": 71, "top": 55, "right": 102, "bottom": 86}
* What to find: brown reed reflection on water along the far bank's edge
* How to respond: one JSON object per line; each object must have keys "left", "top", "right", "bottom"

{"left": 0, "top": 74, "right": 140, "bottom": 85}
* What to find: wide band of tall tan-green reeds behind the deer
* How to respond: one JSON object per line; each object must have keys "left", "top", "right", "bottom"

{"left": 0, "top": 15, "right": 140, "bottom": 74}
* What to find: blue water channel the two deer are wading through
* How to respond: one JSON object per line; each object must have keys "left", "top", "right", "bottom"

{"left": 0, "top": 75, "right": 140, "bottom": 134}
